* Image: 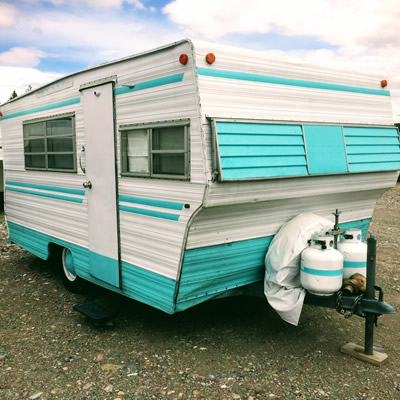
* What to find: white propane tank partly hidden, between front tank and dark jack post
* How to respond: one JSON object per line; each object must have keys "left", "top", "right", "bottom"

{"left": 338, "top": 229, "right": 367, "bottom": 279}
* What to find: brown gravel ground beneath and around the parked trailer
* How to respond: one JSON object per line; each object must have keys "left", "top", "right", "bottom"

{"left": 0, "top": 185, "right": 400, "bottom": 400}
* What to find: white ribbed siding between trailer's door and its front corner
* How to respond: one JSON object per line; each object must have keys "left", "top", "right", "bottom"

{"left": 116, "top": 43, "right": 206, "bottom": 279}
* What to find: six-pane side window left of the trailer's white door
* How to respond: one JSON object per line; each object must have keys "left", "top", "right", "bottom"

{"left": 23, "top": 114, "right": 76, "bottom": 172}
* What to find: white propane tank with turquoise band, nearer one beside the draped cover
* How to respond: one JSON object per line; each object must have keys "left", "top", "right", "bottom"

{"left": 300, "top": 236, "right": 343, "bottom": 296}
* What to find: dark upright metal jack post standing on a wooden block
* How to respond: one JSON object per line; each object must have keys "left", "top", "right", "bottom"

{"left": 364, "top": 233, "right": 376, "bottom": 355}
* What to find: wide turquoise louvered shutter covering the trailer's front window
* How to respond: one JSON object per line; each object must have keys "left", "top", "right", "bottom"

{"left": 213, "top": 121, "right": 400, "bottom": 180}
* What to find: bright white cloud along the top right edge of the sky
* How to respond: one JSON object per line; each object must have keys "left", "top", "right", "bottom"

{"left": 163, "top": 0, "right": 400, "bottom": 44}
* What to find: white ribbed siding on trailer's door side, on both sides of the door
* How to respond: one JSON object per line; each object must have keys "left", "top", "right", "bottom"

{"left": 1, "top": 41, "right": 206, "bottom": 286}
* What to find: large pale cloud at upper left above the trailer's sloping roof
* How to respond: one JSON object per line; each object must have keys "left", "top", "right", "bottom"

{"left": 3, "top": 11, "right": 182, "bottom": 65}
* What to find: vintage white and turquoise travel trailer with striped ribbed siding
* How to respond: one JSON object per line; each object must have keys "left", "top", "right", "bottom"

{"left": 0, "top": 40, "right": 400, "bottom": 314}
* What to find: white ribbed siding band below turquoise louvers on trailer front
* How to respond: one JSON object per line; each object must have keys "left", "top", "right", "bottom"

{"left": 187, "top": 171, "right": 398, "bottom": 249}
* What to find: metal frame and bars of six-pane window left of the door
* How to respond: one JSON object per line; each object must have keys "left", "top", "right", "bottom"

{"left": 22, "top": 113, "right": 77, "bottom": 173}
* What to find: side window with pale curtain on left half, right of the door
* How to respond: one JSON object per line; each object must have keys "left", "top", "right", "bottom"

{"left": 120, "top": 122, "right": 189, "bottom": 179}
